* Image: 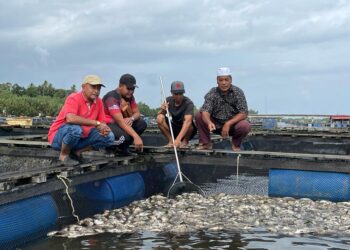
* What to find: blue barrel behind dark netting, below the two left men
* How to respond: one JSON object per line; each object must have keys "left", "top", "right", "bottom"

{"left": 76, "top": 172, "right": 145, "bottom": 208}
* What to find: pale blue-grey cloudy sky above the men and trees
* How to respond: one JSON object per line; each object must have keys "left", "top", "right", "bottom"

{"left": 0, "top": 0, "right": 350, "bottom": 114}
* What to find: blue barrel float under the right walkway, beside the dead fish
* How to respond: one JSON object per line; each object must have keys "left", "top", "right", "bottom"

{"left": 269, "top": 169, "right": 350, "bottom": 201}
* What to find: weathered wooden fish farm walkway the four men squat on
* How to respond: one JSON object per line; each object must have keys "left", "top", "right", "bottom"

{"left": 0, "top": 134, "right": 350, "bottom": 205}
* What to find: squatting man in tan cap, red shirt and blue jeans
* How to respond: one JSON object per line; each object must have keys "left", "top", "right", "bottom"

{"left": 48, "top": 75, "right": 114, "bottom": 165}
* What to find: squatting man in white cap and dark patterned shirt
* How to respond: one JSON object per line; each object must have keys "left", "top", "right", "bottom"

{"left": 195, "top": 67, "right": 250, "bottom": 151}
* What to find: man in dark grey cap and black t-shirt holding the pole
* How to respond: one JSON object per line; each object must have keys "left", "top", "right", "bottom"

{"left": 157, "top": 81, "right": 197, "bottom": 148}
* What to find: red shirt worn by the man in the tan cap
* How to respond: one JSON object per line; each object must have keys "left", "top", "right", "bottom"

{"left": 47, "top": 92, "right": 105, "bottom": 144}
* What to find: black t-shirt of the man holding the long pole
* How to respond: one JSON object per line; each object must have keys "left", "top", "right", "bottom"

{"left": 166, "top": 96, "right": 194, "bottom": 125}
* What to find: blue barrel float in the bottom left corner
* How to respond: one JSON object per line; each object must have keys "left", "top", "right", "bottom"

{"left": 0, "top": 194, "right": 58, "bottom": 249}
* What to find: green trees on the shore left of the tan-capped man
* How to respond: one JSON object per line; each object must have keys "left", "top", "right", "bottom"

{"left": 0, "top": 81, "right": 75, "bottom": 116}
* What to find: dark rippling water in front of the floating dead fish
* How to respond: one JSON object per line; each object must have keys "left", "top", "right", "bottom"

{"left": 23, "top": 230, "right": 350, "bottom": 250}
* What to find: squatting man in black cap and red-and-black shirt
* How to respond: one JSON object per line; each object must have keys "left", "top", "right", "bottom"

{"left": 103, "top": 74, "right": 147, "bottom": 155}
